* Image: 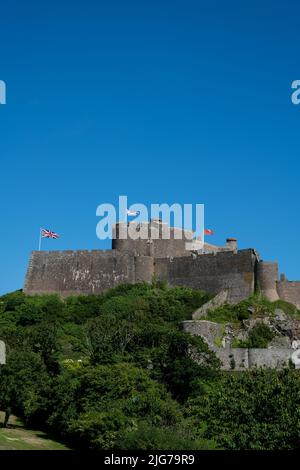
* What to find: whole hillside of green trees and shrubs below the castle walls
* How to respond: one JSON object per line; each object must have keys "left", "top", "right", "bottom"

{"left": 0, "top": 282, "right": 300, "bottom": 450}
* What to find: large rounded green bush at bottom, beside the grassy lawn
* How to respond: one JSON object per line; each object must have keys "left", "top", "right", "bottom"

{"left": 48, "top": 364, "right": 181, "bottom": 449}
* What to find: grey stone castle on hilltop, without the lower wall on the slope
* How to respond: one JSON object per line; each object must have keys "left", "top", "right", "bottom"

{"left": 24, "top": 219, "right": 300, "bottom": 308}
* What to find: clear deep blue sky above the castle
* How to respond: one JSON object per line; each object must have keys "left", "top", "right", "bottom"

{"left": 0, "top": 0, "right": 300, "bottom": 293}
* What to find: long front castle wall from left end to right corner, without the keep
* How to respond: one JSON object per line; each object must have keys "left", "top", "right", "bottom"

{"left": 24, "top": 246, "right": 256, "bottom": 303}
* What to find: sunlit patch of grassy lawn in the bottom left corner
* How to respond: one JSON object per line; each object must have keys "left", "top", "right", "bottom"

{"left": 0, "top": 412, "right": 69, "bottom": 450}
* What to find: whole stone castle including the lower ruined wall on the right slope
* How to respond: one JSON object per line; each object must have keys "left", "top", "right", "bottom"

{"left": 24, "top": 219, "right": 300, "bottom": 370}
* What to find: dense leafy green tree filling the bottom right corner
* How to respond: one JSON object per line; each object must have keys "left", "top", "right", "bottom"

{"left": 187, "top": 369, "right": 300, "bottom": 450}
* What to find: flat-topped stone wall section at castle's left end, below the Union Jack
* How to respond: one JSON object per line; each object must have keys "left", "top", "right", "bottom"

{"left": 24, "top": 250, "right": 135, "bottom": 296}
